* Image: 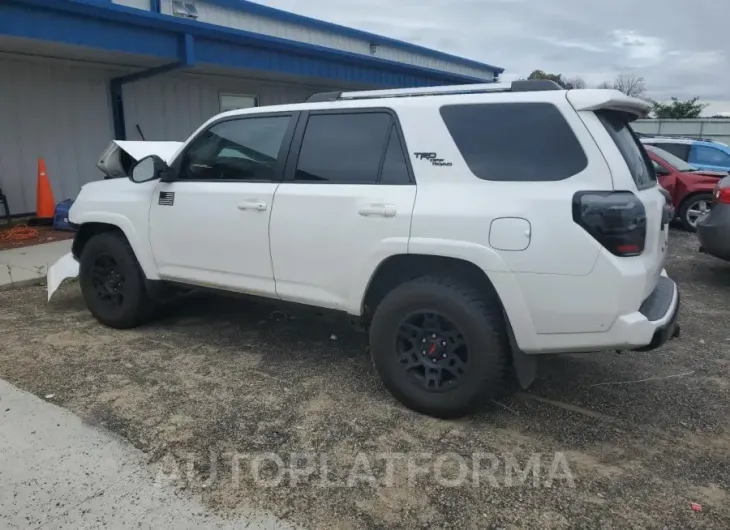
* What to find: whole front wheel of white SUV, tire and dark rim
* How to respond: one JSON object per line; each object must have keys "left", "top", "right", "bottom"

{"left": 79, "top": 232, "right": 155, "bottom": 328}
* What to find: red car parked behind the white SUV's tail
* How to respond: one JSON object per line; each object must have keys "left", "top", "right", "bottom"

{"left": 644, "top": 144, "right": 728, "bottom": 232}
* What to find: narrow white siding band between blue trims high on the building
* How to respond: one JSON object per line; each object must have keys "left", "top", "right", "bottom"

{"left": 156, "top": 0, "right": 494, "bottom": 79}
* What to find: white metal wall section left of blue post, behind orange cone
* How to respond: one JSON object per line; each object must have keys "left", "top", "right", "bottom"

{"left": 0, "top": 56, "right": 112, "bottom": 214}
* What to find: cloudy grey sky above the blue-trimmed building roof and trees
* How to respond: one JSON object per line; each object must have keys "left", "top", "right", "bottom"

{"left": 258, "top": 0, "right": 730, "bottom": 115}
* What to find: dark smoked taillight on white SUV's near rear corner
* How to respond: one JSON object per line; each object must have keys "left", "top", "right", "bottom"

{"left": 573, "top": 191, "right": 646, "bottom": 256}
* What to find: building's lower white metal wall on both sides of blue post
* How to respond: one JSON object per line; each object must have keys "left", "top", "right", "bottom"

{"left": 0, "top": 55, "right": 335, "bottom": 214}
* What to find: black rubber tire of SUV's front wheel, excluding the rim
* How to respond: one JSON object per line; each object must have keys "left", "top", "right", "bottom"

{"left": 79, "top": 232, "right": 156, "bottom": 329}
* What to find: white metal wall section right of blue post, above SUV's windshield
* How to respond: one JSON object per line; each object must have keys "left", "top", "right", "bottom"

{"left": 124, "top": 74, "right": 334, "bottom": 141}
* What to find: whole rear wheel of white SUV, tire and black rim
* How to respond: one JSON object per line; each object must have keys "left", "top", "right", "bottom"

{"left": 370, "top": 277, "right": 510, "bottom": 418}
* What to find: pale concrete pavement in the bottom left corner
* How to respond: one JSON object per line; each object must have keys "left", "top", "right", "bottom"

{"left": 0, "top": 380, "right": 293, "bottom": 530}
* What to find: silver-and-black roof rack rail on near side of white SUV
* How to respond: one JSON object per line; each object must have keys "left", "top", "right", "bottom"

{"left": 306, "top": 79, "right": 563, "bottom": 103}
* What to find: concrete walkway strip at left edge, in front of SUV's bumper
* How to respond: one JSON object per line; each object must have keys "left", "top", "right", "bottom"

{"left": 0, "top": 239, "right": 72, "bottom": 290}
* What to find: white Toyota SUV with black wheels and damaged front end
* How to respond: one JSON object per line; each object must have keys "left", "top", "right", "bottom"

{"left": 49, "top": 81, "right": 679, "bottom": 417}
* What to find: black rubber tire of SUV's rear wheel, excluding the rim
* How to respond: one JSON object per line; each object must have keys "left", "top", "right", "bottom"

{"left": 370, "top": 277, "right": 510, "bottom": 418}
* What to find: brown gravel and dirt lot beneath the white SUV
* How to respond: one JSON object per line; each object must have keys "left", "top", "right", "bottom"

{"left": 0, "top": 232, "right": 730, "bottom": 528}
